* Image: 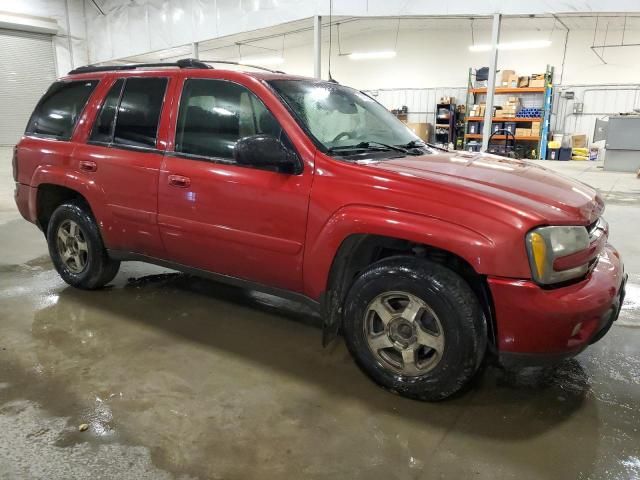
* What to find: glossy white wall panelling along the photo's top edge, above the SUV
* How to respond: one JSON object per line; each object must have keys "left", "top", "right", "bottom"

{"left": 87, "top": 0, "right": 640, "bottom": 62}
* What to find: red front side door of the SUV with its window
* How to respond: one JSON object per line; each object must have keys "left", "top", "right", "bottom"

{"left": 158, "top": 78, "right": 312, "bottom": 291}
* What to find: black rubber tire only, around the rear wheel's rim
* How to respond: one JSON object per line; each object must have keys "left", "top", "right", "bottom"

{"left": 47, "top": 201, "right": 120, "bottom": 290}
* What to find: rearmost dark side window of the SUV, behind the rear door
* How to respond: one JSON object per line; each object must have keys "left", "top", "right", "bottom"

{"left": 26, "top": 80, "right": 98, "bottom": 140}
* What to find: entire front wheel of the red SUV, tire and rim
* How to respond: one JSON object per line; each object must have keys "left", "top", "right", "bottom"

{"left": 343, "top": 256, "right": 487, "bottom": 401}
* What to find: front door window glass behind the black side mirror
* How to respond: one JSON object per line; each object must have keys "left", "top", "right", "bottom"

{"left": 175, "top": 79, "right": 282, "bottom": 159}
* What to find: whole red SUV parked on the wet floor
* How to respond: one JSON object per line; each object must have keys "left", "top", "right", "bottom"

{"left": 14, "top": 60, "right": 626, "bottom": 400}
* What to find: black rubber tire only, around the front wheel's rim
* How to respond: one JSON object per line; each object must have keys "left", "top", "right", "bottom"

{"left": 343, "top": 256, "right": 487, "bottom": 401}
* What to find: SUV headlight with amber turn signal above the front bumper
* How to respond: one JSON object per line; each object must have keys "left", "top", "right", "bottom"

{"left": 526, "top": 227, "right": 589, "bottom": 285}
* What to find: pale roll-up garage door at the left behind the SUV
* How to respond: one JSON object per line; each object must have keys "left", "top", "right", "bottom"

{"left": 0, "top": 29, "right": 56, "bottom": 145}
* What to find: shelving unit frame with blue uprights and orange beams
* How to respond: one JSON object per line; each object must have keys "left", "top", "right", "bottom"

{"left": 464, "top": 65, "right": 553, "bottom": 159}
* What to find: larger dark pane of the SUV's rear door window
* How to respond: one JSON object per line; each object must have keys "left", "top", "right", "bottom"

{"left": 113, "top": 78, "right": 167, "bottom": 148}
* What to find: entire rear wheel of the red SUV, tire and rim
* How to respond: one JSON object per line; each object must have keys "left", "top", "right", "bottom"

{"left": 47, "top": 202, "right": 120, "bottom": 289}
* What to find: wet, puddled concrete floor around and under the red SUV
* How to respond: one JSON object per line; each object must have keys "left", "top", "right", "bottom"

{"left": 0, "top": 151, "right": 640, "bottom": 480}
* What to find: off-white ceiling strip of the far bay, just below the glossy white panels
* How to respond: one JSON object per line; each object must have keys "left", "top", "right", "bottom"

{"left": 116, "top": 14, "right": 640, "bottom": 63}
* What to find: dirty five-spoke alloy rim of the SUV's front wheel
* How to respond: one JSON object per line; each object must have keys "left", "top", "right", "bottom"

{"left": 364, "top": 291, "right": 445, "bottom": 377}
